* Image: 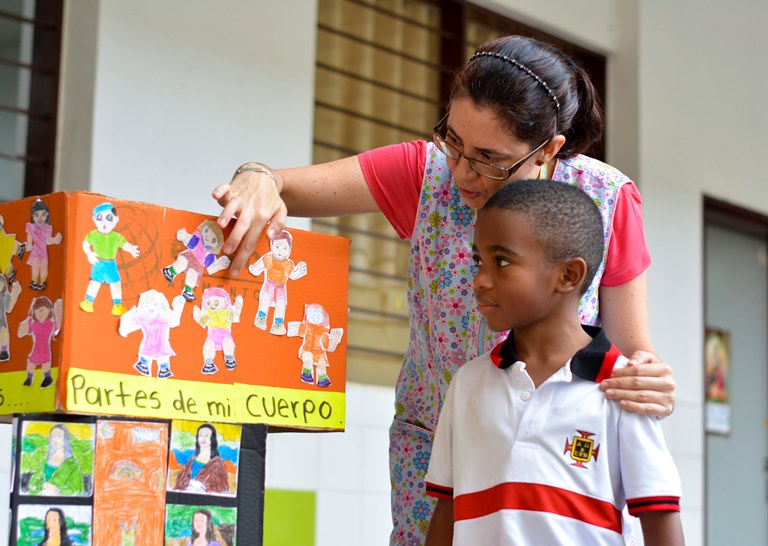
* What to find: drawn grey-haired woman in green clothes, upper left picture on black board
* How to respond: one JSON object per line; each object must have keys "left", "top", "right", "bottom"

{"left": 29, "top": 424, "right": 85, "bottom": 497}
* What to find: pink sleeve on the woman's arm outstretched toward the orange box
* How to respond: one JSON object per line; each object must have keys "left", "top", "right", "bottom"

{"left": 358, "top": 140, "right": 427, "bottom": 239}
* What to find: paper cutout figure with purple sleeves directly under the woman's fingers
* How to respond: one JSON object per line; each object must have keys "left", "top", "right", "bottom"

{"left": 162, "top": 220, "right": 229, "bottom": 301}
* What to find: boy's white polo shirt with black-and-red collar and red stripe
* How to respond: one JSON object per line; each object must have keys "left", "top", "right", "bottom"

{"left": 426, "top": 326, "right": 680, "bottom": 546}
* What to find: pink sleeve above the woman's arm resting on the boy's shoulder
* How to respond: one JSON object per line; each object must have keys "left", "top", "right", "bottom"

{"left": 600, "top": 182, "right": 651, "bottom": 286}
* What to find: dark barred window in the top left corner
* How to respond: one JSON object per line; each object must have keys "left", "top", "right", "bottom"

{"left": 0, "top": 0, "right": 63, "bottom": 201}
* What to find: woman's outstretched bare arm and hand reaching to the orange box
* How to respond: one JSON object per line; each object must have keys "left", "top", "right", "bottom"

{"left": 213, "top": 156, "right": 379, "bottom": 275}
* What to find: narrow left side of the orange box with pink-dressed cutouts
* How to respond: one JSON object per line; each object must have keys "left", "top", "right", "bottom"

{"left": 0, "top": 193, "right": 68, "bottom": 414}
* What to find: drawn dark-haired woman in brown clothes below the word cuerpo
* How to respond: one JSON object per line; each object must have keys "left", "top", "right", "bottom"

{"left": 173, "top": 424, "right": 229, "bottom": 493}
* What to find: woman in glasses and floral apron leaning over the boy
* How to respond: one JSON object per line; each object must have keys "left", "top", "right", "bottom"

{"left": 213, "top": 36, "right": 674, "bottom": 544}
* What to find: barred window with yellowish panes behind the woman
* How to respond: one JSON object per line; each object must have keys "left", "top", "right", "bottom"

{"left": 312, "top": 0, "right": 605, "bottom": 385}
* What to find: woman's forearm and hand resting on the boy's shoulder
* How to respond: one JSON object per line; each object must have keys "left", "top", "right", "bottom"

{"left": 600, "top": 273, "right": 675, "bottom": 417}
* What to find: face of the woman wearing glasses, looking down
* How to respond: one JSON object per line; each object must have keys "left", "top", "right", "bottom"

{"left": 445, "top": 98, "right": 547, "bottom": 210}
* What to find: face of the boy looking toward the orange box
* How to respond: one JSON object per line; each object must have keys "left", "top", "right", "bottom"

{"left": 472, "top": 208, "right": 558, "bottom": 332}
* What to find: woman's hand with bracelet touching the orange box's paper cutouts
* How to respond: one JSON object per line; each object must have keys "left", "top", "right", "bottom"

{"left": 212, "top": 163, "right": 288, "bottom": 276}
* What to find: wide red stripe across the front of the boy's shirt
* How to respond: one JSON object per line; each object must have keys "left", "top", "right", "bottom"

{"left": 453, "top": 482, "right": 621, "bottom": 533}
